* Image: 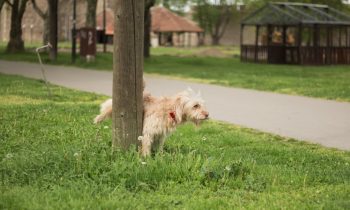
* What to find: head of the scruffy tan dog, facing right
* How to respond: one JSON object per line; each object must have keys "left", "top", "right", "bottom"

{"left": 176, "top": 88, "right": 209, "bottom": 124}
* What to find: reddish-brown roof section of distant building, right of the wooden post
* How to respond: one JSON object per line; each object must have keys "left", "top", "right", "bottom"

{"left": 151, "top": 7, "right": 203, "bottom": 32}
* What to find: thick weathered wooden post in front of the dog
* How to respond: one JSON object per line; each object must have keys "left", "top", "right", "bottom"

{"left": 112, "top": 0, "right": 144, "bottom": 149}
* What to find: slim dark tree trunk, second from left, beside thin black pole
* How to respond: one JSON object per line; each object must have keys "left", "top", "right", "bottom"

{"left": 48, "top": 0, "right": 58, "bottom": 61}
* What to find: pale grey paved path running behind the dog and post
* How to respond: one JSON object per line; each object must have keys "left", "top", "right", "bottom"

{"left": 0, "top": 60, "right": 350, "bottom": 150}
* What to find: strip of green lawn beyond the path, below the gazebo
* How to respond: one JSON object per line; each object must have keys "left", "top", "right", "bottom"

{"left": 0, "top": 44, "right": 350, "bottom": 102}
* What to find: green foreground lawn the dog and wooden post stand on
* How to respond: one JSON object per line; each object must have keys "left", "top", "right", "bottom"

{"left": 0, "top": 74, "right": 350, "bottom": 209}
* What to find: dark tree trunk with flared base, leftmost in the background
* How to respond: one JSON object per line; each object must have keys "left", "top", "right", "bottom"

{"left": 5, "top": 0, "right": 28, "bottom": 53}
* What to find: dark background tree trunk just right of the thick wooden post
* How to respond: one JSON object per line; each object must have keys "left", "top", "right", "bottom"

{"left": 143, "top": 0, "right": 156, "bottom": 58}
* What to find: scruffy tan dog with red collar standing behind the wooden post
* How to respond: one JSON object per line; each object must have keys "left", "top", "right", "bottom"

{"left": 94, "top": 89, "right": 209, "bottom": 156}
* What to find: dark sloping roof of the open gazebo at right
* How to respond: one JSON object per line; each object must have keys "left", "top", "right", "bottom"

{"left": 241, "top": 2, "right": 350, "bottom": 25}
